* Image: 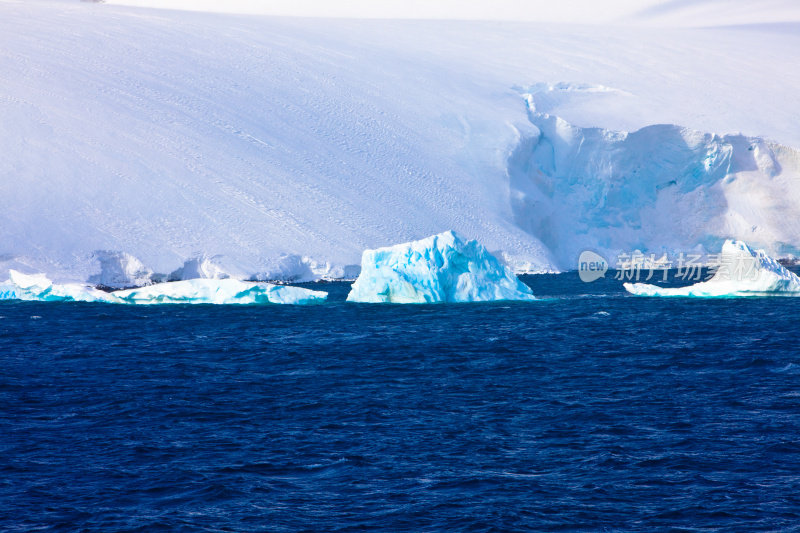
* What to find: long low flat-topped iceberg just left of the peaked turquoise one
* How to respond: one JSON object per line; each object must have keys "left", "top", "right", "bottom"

{"left": 112, "top": 278, "right": 328, "bottom": 305}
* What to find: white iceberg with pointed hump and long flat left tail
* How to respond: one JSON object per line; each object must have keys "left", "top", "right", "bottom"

{"left": 625, "top": 240, "right": 800, "bottom": 298}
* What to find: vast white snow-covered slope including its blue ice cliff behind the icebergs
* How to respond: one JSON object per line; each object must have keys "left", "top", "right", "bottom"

{"left": 0, "top": 0, "right": 800, "bottom": 286}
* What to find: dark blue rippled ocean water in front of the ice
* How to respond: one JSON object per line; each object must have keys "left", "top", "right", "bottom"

{"left": 0, "top": 273, "right": 800, "bottom": 532}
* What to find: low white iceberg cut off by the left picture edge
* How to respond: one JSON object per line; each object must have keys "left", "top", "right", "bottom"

{"left": 0, "top": 270, "right": 116, "bottom": 302}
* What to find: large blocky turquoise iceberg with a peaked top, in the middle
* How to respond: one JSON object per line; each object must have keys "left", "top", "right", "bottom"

{"left": 347, "top": 231, "right": 534, "bottom": 303}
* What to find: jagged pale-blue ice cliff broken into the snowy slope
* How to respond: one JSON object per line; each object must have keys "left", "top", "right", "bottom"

{"left": 509, "top": 83, "right": 800, "bottom": 268}
